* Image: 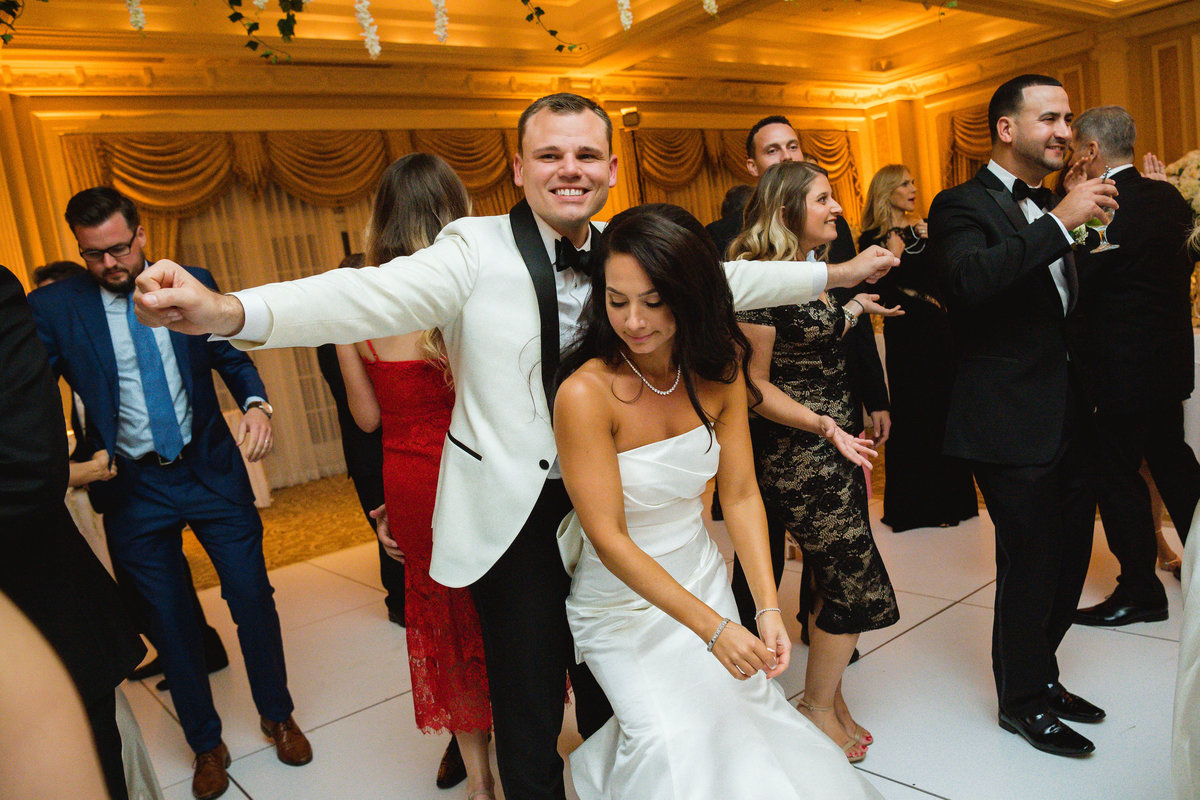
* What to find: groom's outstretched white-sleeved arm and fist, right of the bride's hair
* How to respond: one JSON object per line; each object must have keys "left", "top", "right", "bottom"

{"left": 725, "top": 246, "right": 900, "bottom": 311}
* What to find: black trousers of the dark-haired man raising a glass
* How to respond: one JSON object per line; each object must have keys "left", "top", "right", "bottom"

{"left": 972, "top": 393, "right": 1096, "bottom": 714}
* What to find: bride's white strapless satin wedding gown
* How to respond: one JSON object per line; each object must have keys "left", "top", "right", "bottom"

{"left": 566, "top": 426, "right": 882, "bottom": 800}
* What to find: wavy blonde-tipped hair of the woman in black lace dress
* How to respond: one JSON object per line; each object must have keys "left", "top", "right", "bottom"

{"left": 730, "top": 161, "right": 829, "bottom": 261}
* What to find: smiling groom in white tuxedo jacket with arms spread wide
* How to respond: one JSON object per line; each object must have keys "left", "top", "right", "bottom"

{"left": 137, "top": 94, "right": 896, "bottom": 800}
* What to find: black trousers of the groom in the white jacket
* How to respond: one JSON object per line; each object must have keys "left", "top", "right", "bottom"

{"left": 470, "top": 480, "right": 612, "bottom": 800}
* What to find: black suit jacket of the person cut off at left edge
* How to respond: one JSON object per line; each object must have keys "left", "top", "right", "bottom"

{"left": 0, "top": 266, "right": 145, "bottom": 704}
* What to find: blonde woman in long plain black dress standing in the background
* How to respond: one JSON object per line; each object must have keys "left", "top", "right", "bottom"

{"left": 858, "top": 164, "right": 979, "bottom": 531}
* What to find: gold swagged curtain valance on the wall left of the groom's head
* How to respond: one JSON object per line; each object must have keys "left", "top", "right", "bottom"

{"left": 62, "top": 130, "right": 521, "bottom": 258}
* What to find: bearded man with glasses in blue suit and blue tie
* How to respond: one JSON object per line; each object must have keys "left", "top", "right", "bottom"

{"left": 29, "top": 187, "right": 312, "bottom": 800}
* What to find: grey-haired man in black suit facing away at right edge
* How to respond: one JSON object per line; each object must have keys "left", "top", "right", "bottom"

{"left": 1073, "top": 106, "right": 1200, "bottom": 627}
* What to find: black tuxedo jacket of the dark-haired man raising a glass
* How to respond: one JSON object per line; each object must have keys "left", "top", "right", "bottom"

{"left": 929, "top": 167, "right": 1078, "bottom": 465}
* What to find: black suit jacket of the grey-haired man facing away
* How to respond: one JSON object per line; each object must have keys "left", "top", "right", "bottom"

{"left": 1078, "top": 167, "right": 1194, "bottom": 414}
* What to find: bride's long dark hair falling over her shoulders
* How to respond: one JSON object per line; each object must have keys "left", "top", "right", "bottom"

{"left": 557, "top": 203, "right": 761, "bottom": 431}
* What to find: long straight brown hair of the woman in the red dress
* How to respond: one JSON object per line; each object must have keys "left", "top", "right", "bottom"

{"left": 365, "top": 152, "right": 470, "bottom": 371}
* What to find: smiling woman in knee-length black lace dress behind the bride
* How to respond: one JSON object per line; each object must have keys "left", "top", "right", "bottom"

{"left": 730, "top": 162, "right": 901, "bottom": 762}
